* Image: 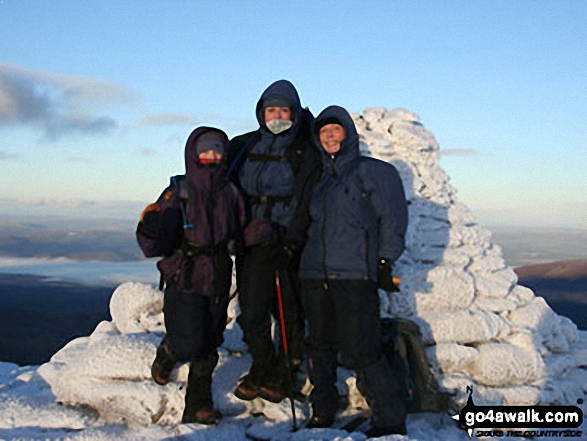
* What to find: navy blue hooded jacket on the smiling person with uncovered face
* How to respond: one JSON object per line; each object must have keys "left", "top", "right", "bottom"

{"left": 300, "top": 106, "right": 407, "bottom": 281}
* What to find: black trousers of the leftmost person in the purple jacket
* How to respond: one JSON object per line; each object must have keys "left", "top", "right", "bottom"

{"left": 164, "top": 283, "right": 228, "bottom": 362}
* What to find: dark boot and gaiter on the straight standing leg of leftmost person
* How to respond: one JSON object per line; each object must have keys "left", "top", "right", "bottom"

{"left": 181, "top": 352, "right": 222, "bottom": 425}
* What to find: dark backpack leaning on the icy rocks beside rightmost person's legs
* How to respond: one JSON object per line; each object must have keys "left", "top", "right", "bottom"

{"left": 381, "top": 318, "right": 455, "bottom": 413}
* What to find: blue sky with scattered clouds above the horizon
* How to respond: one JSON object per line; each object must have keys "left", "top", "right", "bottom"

{"left": 0, "top": 0, "right": 587, "bottom": 229}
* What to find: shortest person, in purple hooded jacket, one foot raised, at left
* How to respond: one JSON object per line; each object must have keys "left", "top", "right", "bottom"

{"left": 137, "top": 127, "right": 245, "bottom": 424}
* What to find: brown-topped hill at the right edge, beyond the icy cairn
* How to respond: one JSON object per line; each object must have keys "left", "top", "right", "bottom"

{"left": 514, "top": 259, "right": 587, "bottom": 329}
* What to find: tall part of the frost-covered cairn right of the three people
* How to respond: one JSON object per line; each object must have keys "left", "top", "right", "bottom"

{"left": 353, "top": 109, "right": 587, "bottom": 410}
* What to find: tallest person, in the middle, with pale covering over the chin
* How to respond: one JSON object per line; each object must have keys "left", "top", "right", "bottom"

{"left": 229, "top": 80, "right": 319, "bottom": 402}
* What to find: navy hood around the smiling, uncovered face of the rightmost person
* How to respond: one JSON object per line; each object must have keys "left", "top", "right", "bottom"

{"left": 312, "top": 106, "right": 360, "bottom": 162}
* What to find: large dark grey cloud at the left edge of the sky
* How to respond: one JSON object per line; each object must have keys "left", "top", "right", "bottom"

{"left": 0, "top": 62, "right": 134, "bottom": 140}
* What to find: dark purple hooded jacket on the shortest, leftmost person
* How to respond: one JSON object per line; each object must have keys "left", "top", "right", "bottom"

{"left": 137, "top": 127, "right": 245, "bottom": 296}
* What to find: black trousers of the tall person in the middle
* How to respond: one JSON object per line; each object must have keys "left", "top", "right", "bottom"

{"left": 237, "top": 245, "right": 305, "bottom": 383}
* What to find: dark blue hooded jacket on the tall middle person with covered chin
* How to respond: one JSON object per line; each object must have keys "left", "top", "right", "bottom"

{"left": 231, "top": 80, "right": 316, "bottom": 228}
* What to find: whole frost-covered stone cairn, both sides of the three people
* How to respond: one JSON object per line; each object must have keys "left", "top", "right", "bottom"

{"left": 38, "top": 109, "right": 587, "bottom": 426}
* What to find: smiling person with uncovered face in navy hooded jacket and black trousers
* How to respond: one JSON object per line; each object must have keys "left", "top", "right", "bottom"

{"left": 300, "top": 106, "right": 407, "bottom": 436}
